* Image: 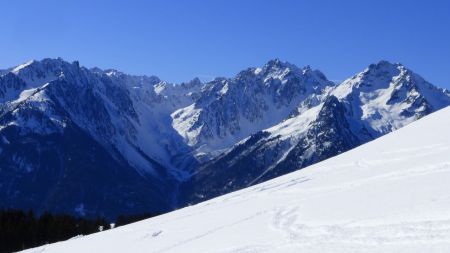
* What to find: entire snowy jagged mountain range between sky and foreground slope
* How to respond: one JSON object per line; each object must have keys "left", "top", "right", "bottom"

{"left": 0, "top": 59, "right": 450, "bottom": 218}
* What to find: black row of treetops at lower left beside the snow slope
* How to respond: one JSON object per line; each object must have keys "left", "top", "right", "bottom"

{"left": 0, "top": 210, "right": 156, "bottom": 253}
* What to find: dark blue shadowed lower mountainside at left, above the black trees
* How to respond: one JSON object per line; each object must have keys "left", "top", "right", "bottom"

{"left": 0, "top": 119, "right": 172, "bottom": 219}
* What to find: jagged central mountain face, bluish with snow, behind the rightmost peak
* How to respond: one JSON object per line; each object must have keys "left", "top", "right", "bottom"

{"left": 172, "top": 59, "right": 334, "bottom": 158}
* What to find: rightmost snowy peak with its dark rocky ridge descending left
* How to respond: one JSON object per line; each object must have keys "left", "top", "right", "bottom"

{"left": 183, "top": 61, "right": 450, "bottom": 202}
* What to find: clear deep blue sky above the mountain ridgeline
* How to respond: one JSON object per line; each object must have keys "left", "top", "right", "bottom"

{"left": 0, "top": 0, "right": 450, "bottom": 88}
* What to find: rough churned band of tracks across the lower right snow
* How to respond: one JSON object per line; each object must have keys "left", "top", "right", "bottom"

{"left": 270, "top": 207, "right": 450, "bottom": 246}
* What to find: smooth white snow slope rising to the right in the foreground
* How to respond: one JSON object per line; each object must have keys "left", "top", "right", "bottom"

{"left": 22, "top": 107, "right": 450, "bottom": 252}
